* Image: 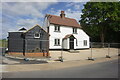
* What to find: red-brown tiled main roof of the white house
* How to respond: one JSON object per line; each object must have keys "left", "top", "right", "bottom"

{"left": 47, "top": 15, "right": 81, "bottom": 28}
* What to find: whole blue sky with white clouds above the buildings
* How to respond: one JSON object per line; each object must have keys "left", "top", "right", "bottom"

{"left": 0, "top": 2, "right": 86, "bottom": 38}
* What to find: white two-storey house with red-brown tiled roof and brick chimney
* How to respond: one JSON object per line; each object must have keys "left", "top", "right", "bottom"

{"left": 43, "top": 11, "right": 89, "bottom": 50}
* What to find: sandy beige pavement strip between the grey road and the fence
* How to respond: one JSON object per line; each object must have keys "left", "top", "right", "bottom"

{"left": 3, "top": 56, "right": 118, "bottom": 72}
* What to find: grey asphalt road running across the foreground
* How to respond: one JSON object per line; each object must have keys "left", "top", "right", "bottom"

{"left": 3, "top": 60, "right": 118, "bottom": 78}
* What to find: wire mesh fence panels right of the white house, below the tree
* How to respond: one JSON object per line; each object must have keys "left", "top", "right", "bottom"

{"left": 88, "top": 42, "right": 120, "bottom": 60}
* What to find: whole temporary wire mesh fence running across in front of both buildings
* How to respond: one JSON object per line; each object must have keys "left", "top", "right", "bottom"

{"left": 2, "top": 39, "right": 120, "bottom": 60}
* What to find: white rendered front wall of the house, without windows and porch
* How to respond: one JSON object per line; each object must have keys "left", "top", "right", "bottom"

{"left": 49, "top": 24, "right": 89, "bottom": 49}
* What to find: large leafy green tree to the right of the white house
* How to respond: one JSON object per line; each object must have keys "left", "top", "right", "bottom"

{"left": 80, "top": 2, "right": 120, "bottom": 43}
